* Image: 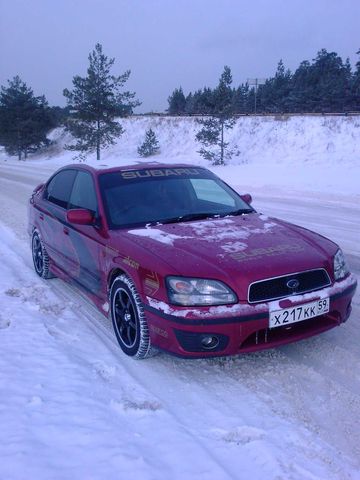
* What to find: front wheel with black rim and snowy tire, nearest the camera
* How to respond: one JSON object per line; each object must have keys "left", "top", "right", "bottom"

{"left": 110, "top": 275, "right": 153, "bottom": 359}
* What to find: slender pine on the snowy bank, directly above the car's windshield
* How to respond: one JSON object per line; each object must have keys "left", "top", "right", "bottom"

{"left": 195, "top": 66, "right": 235, "bottom": 165}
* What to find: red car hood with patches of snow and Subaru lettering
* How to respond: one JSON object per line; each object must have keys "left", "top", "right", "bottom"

{"left": 113, "top": 213, "right": 338, "bottom": 298}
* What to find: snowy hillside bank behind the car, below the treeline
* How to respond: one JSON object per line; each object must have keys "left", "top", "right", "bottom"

{"left": 6, "top": 116, "right": 360, "bottom": 194}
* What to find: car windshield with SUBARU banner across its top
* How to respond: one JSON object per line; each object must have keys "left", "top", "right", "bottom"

{"left": 99, "top": 168, "right": 254, "bottom": 229}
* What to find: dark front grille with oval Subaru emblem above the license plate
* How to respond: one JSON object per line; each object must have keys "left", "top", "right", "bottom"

{"left": 248, "top": 268, "right": 331, "bottom": 303}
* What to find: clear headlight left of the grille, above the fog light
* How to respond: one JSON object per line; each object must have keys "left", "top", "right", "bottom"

{"left": 166, "top": 277, "right": 237, "bottom": 307}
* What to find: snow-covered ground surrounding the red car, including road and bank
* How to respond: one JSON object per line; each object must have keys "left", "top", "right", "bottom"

{"left": 0, "top": 117, "right": 360, "bottom": 480}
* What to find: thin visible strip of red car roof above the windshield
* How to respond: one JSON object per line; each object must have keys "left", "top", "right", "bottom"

{"left": 61, "top": 162, "right": 206, "bottom": 175}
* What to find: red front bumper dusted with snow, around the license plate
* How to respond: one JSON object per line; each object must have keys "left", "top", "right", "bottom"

{"left": 144, "top": 275, "right": 357, "bottom": 358}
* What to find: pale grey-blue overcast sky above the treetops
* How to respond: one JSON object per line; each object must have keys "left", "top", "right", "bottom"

{"left": 0, "top": 0, "right": 360, "bottom": 112}
